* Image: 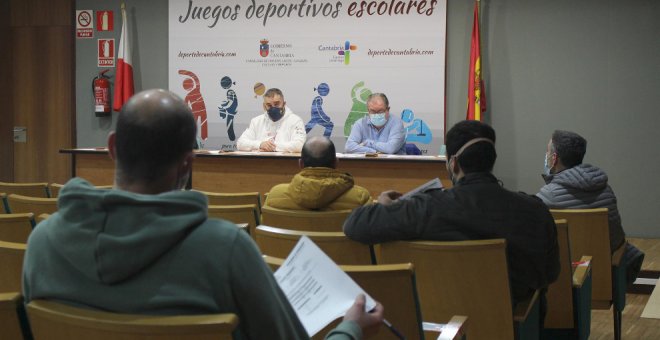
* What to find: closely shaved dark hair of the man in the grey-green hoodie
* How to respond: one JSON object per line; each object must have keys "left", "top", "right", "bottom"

{"left": 115, "top": 90, "right": 197, "bottom": 182}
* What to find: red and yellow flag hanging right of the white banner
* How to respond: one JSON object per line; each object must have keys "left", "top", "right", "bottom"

{"left": 465, "top": 0, "right": 486, "bottom": 120}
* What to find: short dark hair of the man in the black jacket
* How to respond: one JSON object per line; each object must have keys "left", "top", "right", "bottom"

{"left": 445, "top": 120, "right": 497, "bottom": 174}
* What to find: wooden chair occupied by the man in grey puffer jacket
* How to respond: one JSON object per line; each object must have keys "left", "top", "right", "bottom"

{"left": 550, "top": 208, "right": 626, "bottom": 340}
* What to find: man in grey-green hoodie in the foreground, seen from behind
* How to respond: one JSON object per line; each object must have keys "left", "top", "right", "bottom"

{"left": 23, "top": 90, "right": 383, "bottom": 340}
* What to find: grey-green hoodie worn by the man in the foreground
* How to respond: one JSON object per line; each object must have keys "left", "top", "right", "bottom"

{"left": 23, "top": 178, "right": 360, "bottom": 339}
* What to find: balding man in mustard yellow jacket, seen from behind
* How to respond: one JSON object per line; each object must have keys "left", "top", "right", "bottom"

{"left": 264, "top": 137, "right": 371, "bottom": 210}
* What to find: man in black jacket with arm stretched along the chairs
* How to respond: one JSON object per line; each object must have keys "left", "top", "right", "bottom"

{"left": 344, "top": 121, "right": 559, "bottom": 303}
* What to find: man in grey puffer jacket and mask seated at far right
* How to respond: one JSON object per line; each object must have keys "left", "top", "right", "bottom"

{"left": 536, "top": 130, "right": 626, "bottom": 252}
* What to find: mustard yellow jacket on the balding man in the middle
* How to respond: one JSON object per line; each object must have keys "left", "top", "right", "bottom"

{"left": 264, "top": 168, "right": 371, "bottom": 210}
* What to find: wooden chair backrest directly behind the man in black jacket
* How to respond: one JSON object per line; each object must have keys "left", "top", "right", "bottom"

{"left": 381, "top": 239, "right": 514, "bottom": 340}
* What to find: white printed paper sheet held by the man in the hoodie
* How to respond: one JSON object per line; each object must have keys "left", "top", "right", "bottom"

{"left": 274, "top": 236, "right": 376, "bottom": 337}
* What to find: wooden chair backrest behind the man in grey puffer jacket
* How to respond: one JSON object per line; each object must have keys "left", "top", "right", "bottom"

{"left": 550, "top": 208, "right": 612, "bottom": 309}
